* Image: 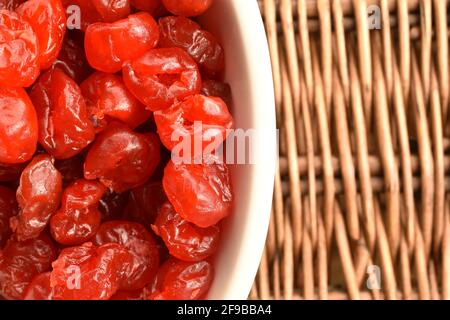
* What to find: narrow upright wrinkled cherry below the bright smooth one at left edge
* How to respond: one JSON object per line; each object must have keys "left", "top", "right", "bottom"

{"left": 11, "top": 154, "right": 62, "bottom": 241}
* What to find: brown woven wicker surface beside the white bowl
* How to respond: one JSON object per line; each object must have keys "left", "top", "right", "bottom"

{"left": 250, "top": 0, "right": 450, "bottom": 299}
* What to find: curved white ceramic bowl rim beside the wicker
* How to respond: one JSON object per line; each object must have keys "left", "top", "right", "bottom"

{"left": 200, "top": 0, "right": 276, "bottom": 300}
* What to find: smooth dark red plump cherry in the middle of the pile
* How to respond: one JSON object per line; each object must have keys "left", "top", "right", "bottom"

{"left": 84, "top": 123, "right": 161, "bottom": 193}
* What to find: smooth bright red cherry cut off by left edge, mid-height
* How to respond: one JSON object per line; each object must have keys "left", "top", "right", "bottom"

{"left": 0, "top": 86, "right": 38, "bottom": 164}
